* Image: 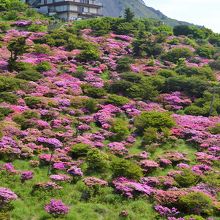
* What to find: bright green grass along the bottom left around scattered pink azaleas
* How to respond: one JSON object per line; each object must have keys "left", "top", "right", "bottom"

{"left": 0, "top": 160, "right": 156, "bottom": 220}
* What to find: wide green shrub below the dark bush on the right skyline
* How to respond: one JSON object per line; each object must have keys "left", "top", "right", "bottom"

{"left": 162, "top": 48, "right": 193, "bottom": 63}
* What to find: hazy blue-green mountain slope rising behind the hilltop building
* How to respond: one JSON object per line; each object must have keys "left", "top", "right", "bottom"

{"left": 100, "top": 0, "right": 191, "bottom": 26}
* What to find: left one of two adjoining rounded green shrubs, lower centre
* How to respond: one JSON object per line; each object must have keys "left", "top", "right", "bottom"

{"left": 86, "top": 148, "right": 109, "bottom": 172}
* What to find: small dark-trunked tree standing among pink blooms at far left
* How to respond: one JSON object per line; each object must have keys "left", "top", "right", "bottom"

{"left": 7, "top": 37, "right": 28, "bottom": 70}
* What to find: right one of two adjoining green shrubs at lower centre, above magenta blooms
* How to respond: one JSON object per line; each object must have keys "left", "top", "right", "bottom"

{"left": 111, "top": 158, "right": 143, "bottom": 180}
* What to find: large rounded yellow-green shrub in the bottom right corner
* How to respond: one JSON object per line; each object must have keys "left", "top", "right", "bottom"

{"left": 179, "top": 192, "right": 213, "bottom": 215}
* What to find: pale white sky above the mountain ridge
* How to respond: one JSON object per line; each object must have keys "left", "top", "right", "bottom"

{"left": 144, "top": 0, "right": 220, "bottom": 33}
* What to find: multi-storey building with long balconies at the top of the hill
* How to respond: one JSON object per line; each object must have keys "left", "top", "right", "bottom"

{"left": 24, "top": 0, "right": 102, "bottom": 21}
